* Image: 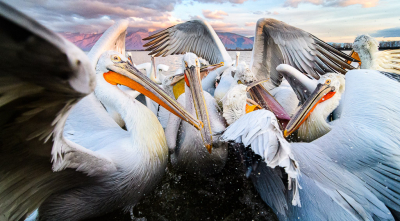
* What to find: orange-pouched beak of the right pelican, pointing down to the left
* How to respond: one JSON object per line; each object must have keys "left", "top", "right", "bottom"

{"left": 283, "top": 84, "right": 336, "bottom": 137}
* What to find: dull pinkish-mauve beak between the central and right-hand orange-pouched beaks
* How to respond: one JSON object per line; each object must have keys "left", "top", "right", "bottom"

{"left": 247, "top": 80, "right": 290, "bottom": 130}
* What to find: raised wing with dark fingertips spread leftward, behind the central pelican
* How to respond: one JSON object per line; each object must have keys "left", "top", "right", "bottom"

{"left": 143, "top": 20, "right": 232, "bottom": 64}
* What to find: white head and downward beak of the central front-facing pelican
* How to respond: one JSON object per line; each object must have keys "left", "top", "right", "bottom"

{"left": 182, "top": 53, "right": 212, "bottom": 153}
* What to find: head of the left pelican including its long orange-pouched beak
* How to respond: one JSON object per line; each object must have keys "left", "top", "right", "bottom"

{"left": 95, "top": 51, "right": 202, "bottom": 129}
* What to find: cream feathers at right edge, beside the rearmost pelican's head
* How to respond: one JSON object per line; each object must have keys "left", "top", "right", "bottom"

{"left": 374, "top": 49, "right": 400, "bottom": 74}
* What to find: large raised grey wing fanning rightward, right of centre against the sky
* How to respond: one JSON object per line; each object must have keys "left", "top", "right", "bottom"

{"left": 250, "top": 18, "right": 354, "bottom": 89}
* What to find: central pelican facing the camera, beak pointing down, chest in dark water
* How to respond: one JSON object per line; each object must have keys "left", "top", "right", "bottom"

{"left": 165, "top": 53, "right": 228, "bottom": 175}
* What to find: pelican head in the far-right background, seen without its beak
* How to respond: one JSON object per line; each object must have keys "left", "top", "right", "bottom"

{"left": 353, "top": 34, "right": 379, "bottom": 69}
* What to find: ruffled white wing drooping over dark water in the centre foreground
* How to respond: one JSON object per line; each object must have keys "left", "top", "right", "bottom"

{"left": 221, "top": 110, "right": 300, "bottom": 213}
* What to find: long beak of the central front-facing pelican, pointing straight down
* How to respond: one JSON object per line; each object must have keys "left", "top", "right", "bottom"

{"left": 185, "top": 66, "right": 212, "bottom": 153}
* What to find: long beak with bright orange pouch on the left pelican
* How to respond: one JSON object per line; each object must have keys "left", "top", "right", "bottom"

{"left": 103, "top": 62, "right": 203, "bottom": 130}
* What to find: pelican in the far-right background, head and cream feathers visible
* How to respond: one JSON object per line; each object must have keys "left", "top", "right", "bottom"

{"left": 353, "top": 35, "right": 400, "bottom": 74}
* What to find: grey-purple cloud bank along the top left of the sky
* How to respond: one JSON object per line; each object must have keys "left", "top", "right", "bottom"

{"left": 3, "top": 0, "right": 181, "bottom": 33}
